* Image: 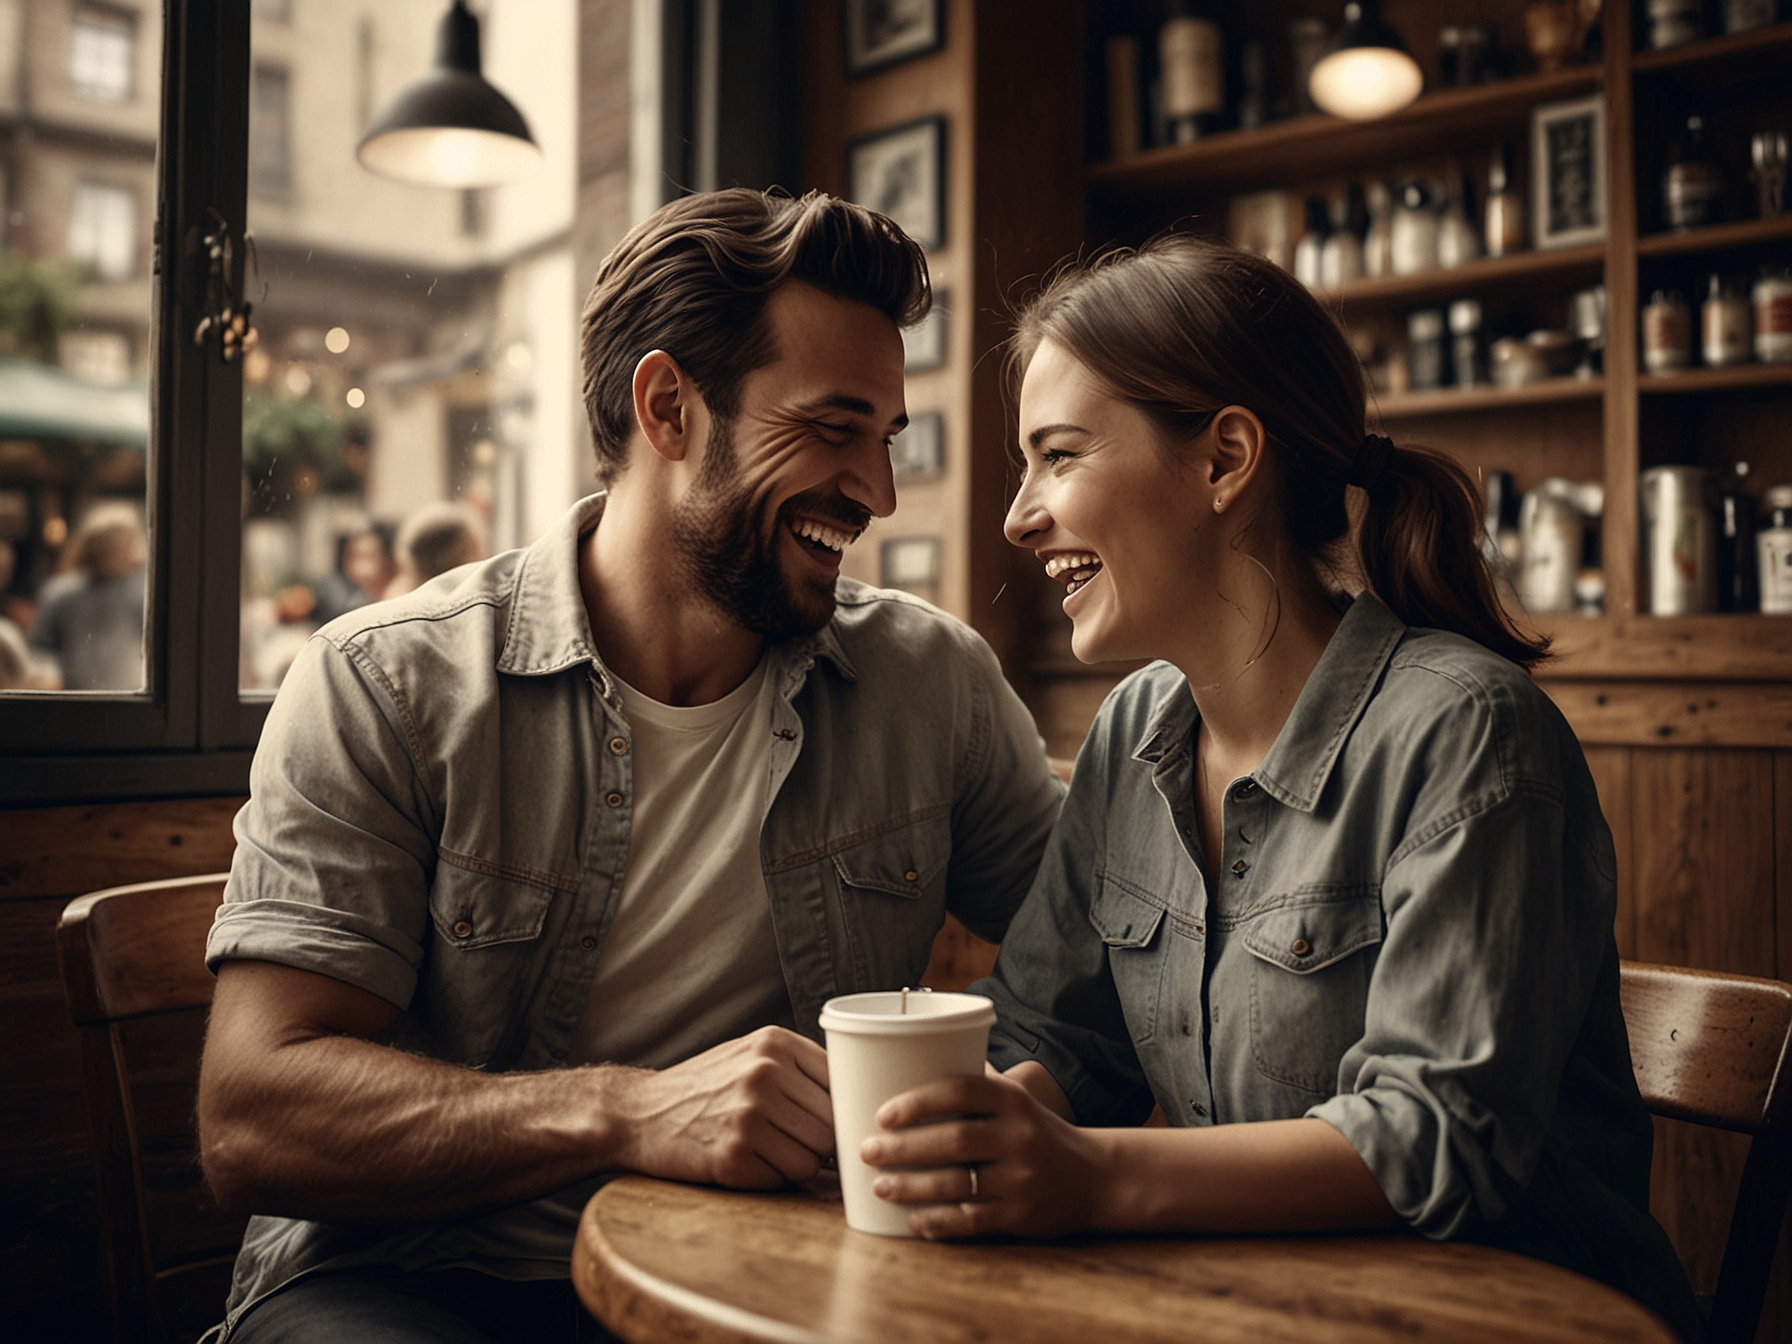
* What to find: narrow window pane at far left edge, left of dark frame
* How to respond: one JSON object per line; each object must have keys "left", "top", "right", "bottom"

{"left": 0, "top": 0, "right": 161, "bottom": 694}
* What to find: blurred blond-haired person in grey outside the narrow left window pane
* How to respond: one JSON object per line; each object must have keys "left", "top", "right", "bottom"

{"left": 30, "top": 502, "right": 149, "bottom": 690}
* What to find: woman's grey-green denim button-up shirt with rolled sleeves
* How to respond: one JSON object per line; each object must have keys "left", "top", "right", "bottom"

{"left": 973, "top": 597, "right": 1697, "bottom": 1331}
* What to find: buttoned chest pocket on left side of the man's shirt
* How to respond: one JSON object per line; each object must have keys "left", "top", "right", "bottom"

{"left": 415, "top": 858, "right": 572, "bottom": 1066}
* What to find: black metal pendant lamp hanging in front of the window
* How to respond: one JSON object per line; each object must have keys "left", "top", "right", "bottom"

{"left": 355, "top": 0, "right": 541, "bottom": 186}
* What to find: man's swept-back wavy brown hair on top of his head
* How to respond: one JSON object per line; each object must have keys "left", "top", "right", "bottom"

{"left": 581, "top": 186, "right": 934, "bottom": 482}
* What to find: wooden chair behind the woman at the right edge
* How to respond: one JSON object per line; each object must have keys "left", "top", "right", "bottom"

{"left": 1620, "top": 962, "right": 1792, "bottom": 1344}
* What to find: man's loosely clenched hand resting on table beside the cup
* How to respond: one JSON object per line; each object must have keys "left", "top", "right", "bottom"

{"left": 609, "top": 1027, "right": 833, "bottom": 1190}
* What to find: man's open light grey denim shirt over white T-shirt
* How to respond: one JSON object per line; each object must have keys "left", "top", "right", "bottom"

{"left": 206, "top": 496, "right": 1063, "bottom": 1340}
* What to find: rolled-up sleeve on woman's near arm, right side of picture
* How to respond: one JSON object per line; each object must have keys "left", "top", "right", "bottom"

{"left": 1308, "top": 781, "right": 1613, "bottom": 1238}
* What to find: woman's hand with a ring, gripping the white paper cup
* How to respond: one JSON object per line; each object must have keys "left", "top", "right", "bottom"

{"left": 858, "top": 1073, "right": 1107, "bottom": 1238}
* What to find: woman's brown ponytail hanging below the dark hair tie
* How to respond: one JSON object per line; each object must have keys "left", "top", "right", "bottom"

{"left": 1349, "top": 434, "right": 1550, "bottom": 668}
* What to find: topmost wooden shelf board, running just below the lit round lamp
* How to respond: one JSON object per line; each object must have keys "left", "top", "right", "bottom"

{"left": 1090, "top": 65, "right": 1600, "bottom": 201}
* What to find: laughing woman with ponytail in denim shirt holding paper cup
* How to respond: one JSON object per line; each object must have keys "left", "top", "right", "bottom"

{"left": 866, "top": 237, "right": 1699, "bottom": 1333}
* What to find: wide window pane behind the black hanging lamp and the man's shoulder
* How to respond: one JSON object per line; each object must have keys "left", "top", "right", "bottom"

{"left": 240, "top": 0, "right": 577, "bottom": 692}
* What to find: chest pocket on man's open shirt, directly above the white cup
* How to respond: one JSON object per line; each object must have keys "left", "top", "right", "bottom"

{"left": 826, "top": 808, "right": 952, "bottom": 989}
